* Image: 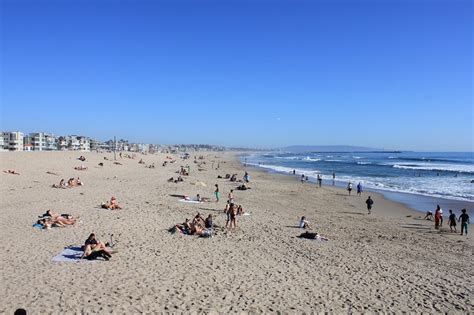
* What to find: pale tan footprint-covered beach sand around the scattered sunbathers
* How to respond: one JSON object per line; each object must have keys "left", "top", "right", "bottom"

{"left": 0, "top": 152, "right": 474, "bottom": 314}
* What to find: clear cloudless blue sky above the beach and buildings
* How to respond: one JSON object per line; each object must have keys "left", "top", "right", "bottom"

{"left": 0, "top": 0, "right": 474, "bottom": 151}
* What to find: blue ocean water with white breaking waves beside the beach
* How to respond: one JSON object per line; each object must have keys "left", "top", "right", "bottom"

{"left": 242, "top": 152, "right": 474, "bottom": 216}
